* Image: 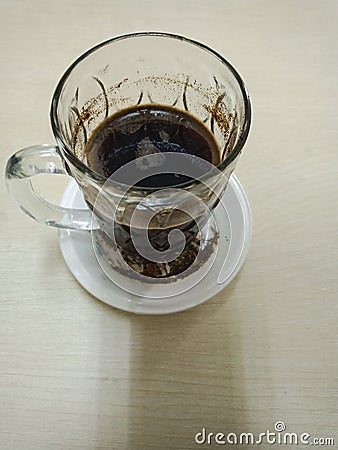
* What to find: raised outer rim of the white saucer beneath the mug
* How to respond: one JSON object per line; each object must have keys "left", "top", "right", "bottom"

{"left": 58, "top": 174, "right": 252, "bottom": 315}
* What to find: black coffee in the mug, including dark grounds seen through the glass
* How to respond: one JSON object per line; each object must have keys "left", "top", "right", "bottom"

{"left": 85, "top": 104, "right": 220, "bottom": 277}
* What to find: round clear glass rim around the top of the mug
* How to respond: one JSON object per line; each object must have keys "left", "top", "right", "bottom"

{"left": 50, "top": 31, "right": 251, "bottom": 191}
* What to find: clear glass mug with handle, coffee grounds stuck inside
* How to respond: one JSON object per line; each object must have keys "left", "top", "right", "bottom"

{"left": 6, "top": 32, "right": 251, "bottom": 280}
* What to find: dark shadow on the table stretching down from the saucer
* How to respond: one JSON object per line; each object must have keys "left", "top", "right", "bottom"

{"left": 126, "top": 277, "right": 245, "bottom": 450}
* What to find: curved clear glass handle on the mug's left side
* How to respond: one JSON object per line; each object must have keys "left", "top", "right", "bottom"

{"left": 5, "top": 144, "right": 96, "bottom": 230}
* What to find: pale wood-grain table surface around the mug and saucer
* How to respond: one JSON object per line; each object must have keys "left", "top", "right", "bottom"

{"left": 0, "top": 0, "right": 338, "bottom": 450}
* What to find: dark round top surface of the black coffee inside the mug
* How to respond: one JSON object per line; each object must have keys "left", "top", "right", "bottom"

{"left": 85, "top": 105, "right": 220, "bottom": 187}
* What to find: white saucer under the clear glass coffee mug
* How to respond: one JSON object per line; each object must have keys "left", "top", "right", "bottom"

{"left": 59, "top": 175, "right": 252, "bottom": 314}
